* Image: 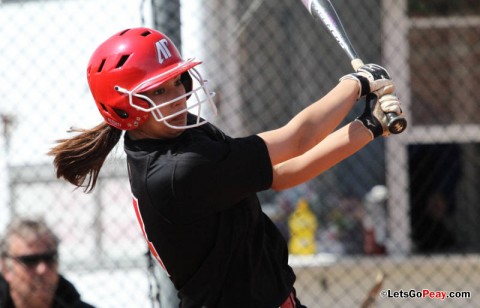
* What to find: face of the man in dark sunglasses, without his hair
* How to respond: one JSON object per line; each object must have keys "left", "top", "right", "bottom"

{"left": 2, "top": 236, "right": 59, "bottom": 307}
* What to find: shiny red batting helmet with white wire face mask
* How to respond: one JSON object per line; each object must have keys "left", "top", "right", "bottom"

{"left": 87, "top": 28, "right": 216, "bottom": 130}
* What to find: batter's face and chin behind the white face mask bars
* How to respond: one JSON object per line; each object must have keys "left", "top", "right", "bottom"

{"left": 130, "top": 75, "right": 187, "bottom": 138}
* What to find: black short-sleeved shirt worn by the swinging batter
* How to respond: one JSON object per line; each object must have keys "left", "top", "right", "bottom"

{"left": 125, "top": 115, "right": 295, "bottom": 308}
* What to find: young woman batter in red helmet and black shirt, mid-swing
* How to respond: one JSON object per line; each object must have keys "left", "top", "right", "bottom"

{"left": 49, "top": 28, "right": 401, "bottom": 308}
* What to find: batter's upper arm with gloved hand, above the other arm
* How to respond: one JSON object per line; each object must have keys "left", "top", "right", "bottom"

{"left": 259, "top": 64, "right": 393, "bottom": 165}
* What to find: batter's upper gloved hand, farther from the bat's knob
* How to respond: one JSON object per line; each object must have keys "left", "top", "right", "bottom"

{"left": 340, "top": 64, "right": 395, "bottom": 98}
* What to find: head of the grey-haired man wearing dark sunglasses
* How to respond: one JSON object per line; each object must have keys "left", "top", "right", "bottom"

{"left": 0, "top": 219, "right": 59, "bottom": 307}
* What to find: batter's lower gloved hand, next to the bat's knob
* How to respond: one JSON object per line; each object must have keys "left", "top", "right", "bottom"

{"left": 356, "top": 93, "right": 402, "bottom": 139}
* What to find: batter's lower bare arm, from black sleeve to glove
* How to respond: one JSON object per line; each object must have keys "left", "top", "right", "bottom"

{"left": 272, "top": 121, "right": 372, "bottom": 190}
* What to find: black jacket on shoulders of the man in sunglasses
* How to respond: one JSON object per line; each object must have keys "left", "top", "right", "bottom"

{"left": 0, "top": 275, "right": 94, "bottom": 308}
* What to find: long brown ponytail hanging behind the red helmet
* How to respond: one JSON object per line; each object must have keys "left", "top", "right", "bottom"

{"left": 47, "top": 122, "right": 122, "bottom": 193}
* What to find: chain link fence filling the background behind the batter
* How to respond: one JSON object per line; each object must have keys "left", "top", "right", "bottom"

{"left": 0, "top": 0, "right": 480, "bottom": 307}
